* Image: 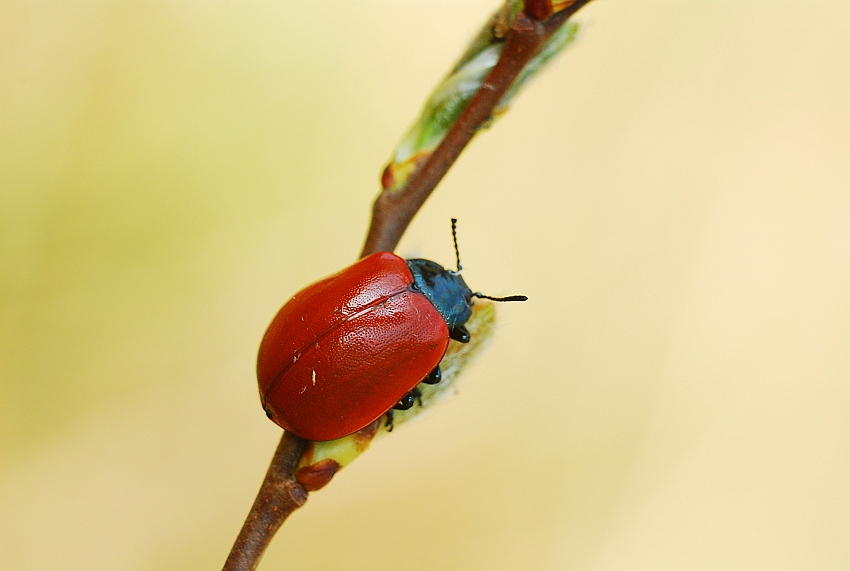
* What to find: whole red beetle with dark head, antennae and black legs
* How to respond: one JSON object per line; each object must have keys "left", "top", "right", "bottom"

{"left": 257, "top": 219, "right": 527, "bottom": 440}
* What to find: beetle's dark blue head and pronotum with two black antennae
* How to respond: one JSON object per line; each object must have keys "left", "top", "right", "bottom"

{"left": 407, "top": 218, "right": 528, "bottom": 330}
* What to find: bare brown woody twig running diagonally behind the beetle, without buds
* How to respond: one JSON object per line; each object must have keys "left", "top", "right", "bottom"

{"left": 223, "top": 0, "right": 591, "bottom": 571}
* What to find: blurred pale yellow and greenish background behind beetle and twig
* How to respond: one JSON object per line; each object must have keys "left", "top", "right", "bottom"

{"left": 0, "top": 0, "right": 850, "bottom": 571}
